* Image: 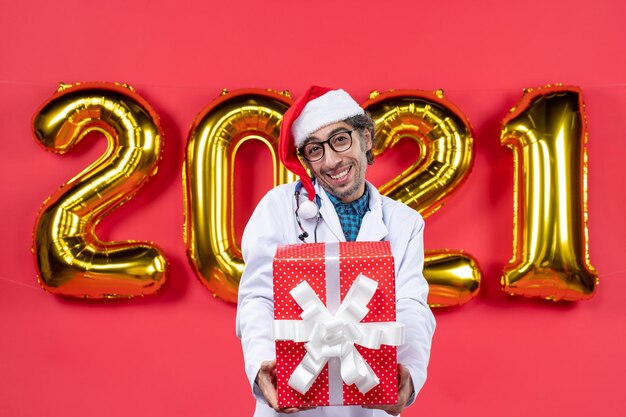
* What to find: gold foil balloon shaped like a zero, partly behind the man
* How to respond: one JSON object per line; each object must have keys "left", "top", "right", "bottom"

{"left": 184, "top": 89, "right": 296, "bottom": 302}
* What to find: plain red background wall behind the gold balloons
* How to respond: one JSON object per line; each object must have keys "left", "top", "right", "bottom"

{"left": 0, "top": 0, "right": 626, "bottom": 417}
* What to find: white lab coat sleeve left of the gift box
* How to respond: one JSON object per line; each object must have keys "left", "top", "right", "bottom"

{"left": 236, "top": 188, "right": 288, "bottom": 401}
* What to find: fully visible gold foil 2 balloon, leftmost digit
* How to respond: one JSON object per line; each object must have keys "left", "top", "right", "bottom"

{"left": 33, "top": 83, "right": 167, "bottom": 298}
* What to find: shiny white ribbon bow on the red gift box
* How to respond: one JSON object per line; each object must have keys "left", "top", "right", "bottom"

{"left": 274, "top": 274, "right": 404, "bottom": 394}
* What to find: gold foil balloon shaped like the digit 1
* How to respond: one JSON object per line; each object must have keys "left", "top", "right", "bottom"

{"left": 500, "top": 86, "right": 598, "bottom": 300}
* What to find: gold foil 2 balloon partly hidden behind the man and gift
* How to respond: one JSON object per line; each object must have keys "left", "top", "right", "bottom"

{"left": 363, "top": 90, "right": 481, "bottom": 307}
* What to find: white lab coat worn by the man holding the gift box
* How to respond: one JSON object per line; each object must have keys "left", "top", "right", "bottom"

{"left": 236, "top": 183, "right": 435, "bottom": 417}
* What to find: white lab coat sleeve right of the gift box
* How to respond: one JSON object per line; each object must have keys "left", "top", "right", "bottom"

{"left": 396, "top": 211, "right": 435, "bottom": 404}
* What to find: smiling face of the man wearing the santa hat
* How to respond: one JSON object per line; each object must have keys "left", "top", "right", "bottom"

{"left": 305, "top": 122, "right": 372, "bottom": 203}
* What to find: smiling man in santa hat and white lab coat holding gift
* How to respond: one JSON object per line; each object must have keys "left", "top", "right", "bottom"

{"left": 237, "top": 86, "right": 435, "bottom": 417}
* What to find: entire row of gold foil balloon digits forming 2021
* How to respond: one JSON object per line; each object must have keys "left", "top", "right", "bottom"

{"left": 33, "top": 83, "right": 598, "bottom": 307}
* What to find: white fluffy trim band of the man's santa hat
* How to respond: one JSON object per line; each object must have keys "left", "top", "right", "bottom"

{"left": 291, "top": 90, "right": 365, "bottom": 148}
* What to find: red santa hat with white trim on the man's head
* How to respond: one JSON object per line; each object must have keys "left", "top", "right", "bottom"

{"left": 278, "top": 85, "right": 365, "bottom": 214}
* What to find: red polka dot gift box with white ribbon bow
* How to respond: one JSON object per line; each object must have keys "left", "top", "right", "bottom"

{"left": 273, "top": 242, "right": 404, "bottom": 407}
